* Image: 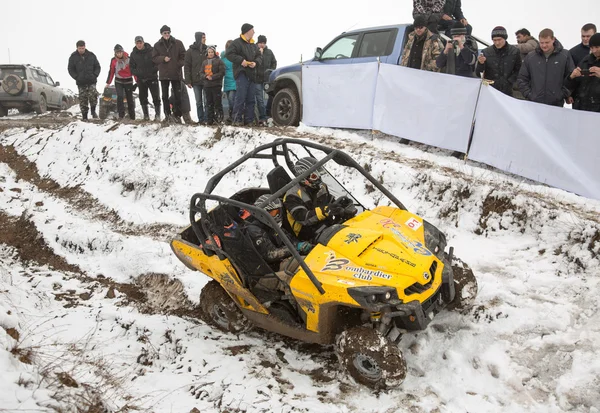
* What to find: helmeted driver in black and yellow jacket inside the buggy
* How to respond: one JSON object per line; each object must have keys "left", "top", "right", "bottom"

{"left": 283, "top": 157, "right": 356, "bottom": 240}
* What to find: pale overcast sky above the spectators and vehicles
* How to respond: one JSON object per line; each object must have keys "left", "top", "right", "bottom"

{"left": 0, "top": 0, "right": 600, "bottom": 91}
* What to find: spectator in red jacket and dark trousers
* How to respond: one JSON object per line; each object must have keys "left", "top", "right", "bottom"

{"left": 107, "top": 44, "right": 137, "bottom": 120}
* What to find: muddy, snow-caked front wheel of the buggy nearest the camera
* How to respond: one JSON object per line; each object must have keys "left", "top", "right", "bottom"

{"left": 335, "top": 327, "right": 406, "bottom": 389}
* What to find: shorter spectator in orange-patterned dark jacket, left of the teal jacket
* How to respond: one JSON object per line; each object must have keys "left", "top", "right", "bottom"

{"left": 200, "top": 46, "right": 225, "bottom": 125}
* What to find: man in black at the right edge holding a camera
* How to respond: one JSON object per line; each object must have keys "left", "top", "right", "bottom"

{"left": 565, "top": 33, "right": 600, "bottom": 113}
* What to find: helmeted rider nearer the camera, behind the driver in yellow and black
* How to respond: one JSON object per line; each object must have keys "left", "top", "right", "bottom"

{"left": 246, "top": 194, "right": 313, "bottom": 264}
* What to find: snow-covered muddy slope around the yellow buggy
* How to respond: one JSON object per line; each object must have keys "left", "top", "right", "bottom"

{"left": 0, "top": 116, "right": 600, "bottom": 413}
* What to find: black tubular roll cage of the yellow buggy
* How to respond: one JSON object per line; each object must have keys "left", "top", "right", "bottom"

{"left": 189, "top": 138, "right": 406, "bottom": 294}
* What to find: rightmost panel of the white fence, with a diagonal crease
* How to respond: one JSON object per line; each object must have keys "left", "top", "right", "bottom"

{"left": 469, "top": 87, "right": 600, "bottom": 199}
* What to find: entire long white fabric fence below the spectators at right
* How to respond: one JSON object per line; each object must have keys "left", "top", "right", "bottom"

{"left": 302, "top": 62, "right": 600, "bottom": 199}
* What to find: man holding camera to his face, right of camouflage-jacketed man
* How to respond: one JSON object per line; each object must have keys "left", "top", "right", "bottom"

{"left": 436, "top": 21, "right": 477, "bottom": 77}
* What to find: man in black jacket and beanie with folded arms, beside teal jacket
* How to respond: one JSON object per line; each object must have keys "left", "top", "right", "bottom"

{"left": 226, "top": 23, "right": 263, "bottom": 125}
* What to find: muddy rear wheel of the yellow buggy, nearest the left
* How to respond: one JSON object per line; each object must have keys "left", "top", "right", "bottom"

{"left": 200, "top": 280, "right": 252, "bottom": 334}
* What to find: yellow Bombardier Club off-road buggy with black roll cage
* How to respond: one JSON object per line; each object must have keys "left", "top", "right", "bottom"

{"left": 171, "top": 139, "right": 477, "bottom": 388}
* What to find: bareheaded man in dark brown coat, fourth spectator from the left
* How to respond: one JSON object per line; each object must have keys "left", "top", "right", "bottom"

{"left": 152, "top": 24, "right": 185, "bottom": 123}
